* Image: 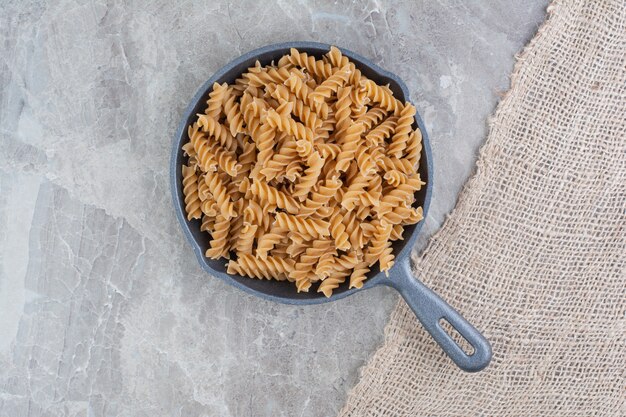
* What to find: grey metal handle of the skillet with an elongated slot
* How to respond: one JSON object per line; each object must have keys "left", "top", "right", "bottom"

{"left": 385, "top": 257, "right": 491, "bottom": 372}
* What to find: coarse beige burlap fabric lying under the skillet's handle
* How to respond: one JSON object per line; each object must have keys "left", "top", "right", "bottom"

{"left": 340, "top": 0, "right": 626, "bottom": 417}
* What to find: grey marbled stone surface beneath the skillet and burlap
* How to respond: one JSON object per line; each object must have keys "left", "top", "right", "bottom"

{"left": 0, "top": 0, "right": 547, "bottom": 417}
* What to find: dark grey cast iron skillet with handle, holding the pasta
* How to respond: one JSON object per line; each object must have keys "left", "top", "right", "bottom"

{"left": 170, "top": 42, "right": 491, "bottom": 372}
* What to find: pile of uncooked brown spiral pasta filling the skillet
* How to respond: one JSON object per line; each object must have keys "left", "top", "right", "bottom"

{"left": 182, "top": 47, "right": 424, "bottom": 297}
